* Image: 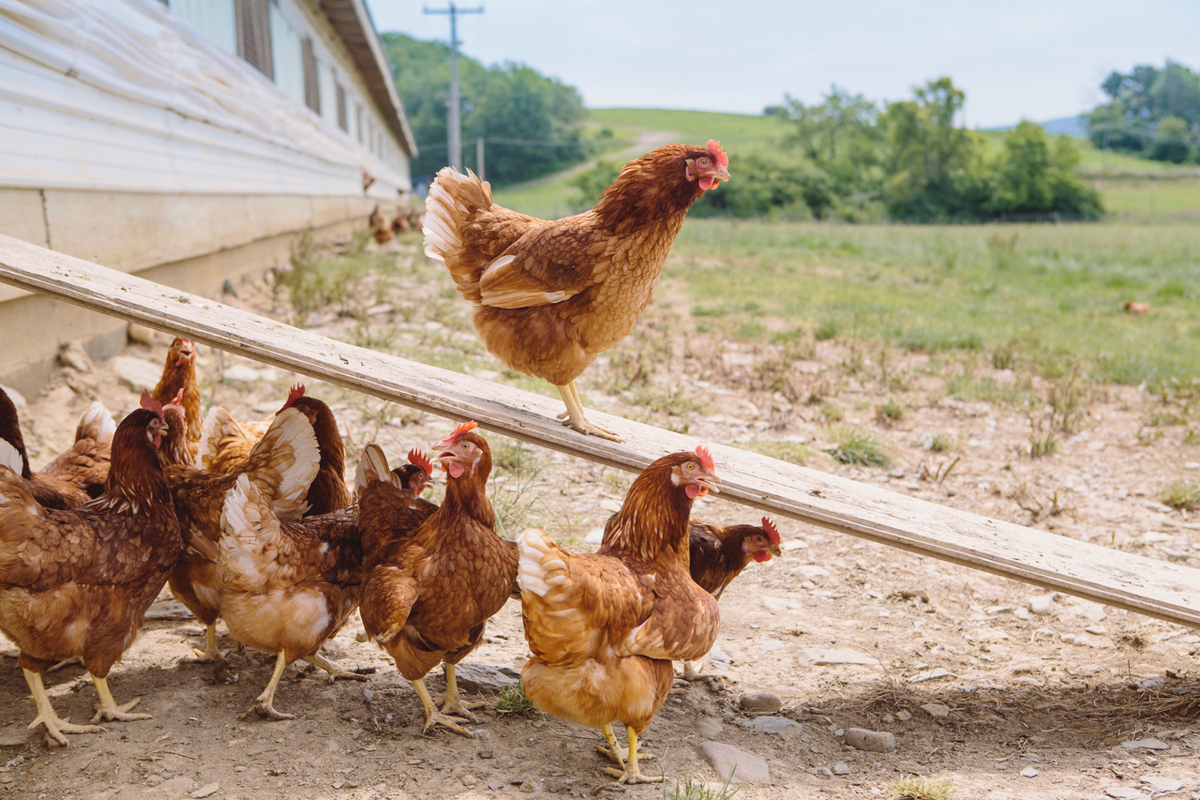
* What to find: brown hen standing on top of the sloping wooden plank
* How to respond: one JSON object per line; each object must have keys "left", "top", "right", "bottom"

{"left": 425, "top": 140, "right": 730, "bottom": 441}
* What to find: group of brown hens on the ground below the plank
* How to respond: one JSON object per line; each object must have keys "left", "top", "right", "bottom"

{"left": 0, "top": 338, "right": 779, "bottom": 782}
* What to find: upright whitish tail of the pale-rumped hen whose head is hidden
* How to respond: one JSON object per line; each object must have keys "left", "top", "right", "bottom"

{"left": 217, "top": 474, "right": 281, "bottom": 590}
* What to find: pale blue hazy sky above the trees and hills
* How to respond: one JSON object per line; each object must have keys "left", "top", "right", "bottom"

{"left": 366, "top": 0, "right": 1200, "bottom": 127}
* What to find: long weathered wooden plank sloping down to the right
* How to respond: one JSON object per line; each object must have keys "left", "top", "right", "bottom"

{"left": 0, "top": 236, "right": 1200, "bottom": 626}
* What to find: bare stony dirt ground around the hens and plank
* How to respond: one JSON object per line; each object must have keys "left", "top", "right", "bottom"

{"left": 0, "top": 237, "right": 1200, "bottom": 800}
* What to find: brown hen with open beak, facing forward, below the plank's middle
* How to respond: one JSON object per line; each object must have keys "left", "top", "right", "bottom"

{"left": 359, "top": 422, "right": 517, "bottom": 736}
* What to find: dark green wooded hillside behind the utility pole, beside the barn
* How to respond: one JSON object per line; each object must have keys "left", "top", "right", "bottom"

{"left": 380, "top": 34, "right": 588, "bottom": 185}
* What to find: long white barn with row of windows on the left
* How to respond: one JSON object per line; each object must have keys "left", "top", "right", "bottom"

{"left": 0, "top": 0, "right": 416, "bottom": 389}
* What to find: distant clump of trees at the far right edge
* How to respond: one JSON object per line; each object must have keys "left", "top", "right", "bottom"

{"left": 1087, "top": 60, "right": 1200, "bottom": 164}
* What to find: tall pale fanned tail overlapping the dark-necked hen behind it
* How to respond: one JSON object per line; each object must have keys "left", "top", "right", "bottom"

{"left": 242, "top": 408, "right": 320, "bottom": 519}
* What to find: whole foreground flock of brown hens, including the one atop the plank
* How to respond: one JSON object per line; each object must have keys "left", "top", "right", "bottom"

{"left": 0, "top": 142, "right": 796, "bottom": 783}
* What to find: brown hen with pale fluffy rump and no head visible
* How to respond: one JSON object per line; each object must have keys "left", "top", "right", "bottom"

{"left": 217, "top": 473, "right": 366, "bottom": 720}
